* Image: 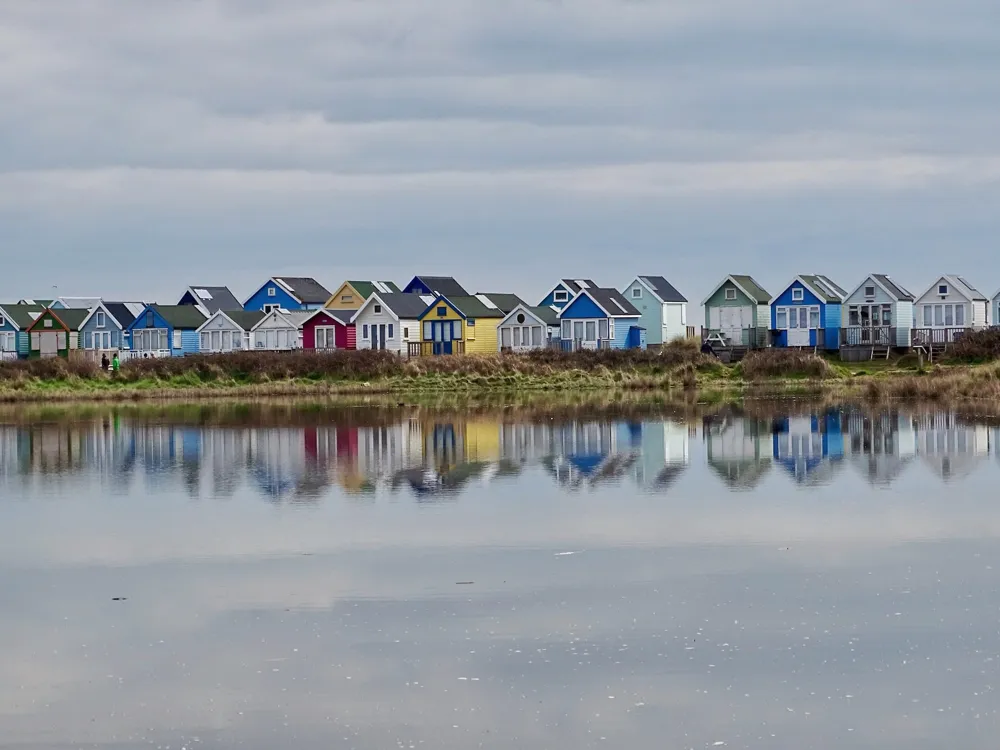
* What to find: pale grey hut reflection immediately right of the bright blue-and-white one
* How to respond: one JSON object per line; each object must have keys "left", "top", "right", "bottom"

{"left": 845, "top": 409, "right": 915, "bottom": 487}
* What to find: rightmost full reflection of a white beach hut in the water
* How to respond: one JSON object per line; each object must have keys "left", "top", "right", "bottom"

{"left": 912, "top": 411, "right": 989, "bottom": 481}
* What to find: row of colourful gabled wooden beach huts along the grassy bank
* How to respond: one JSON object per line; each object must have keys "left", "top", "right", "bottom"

{"left": 0, "top": 274, "right": 1000, "bottom": 360}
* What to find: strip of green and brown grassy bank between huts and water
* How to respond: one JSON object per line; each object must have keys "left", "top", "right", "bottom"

{"left": 0, "top": 339, "right": 1000, "bottom": 402}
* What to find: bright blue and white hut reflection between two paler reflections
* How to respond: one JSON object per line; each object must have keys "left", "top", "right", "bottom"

{"left": 771, "top": 410, "right": 844, "bottom": 484}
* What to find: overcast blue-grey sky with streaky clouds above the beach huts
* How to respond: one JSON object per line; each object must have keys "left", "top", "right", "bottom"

{"left": 0, "top": 0, "right": 1000, "bottom": 303}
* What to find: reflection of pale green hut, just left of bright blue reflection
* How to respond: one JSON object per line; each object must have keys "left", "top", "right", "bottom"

{"left": 703, "top": 414, "right": 771, "bottom": 490}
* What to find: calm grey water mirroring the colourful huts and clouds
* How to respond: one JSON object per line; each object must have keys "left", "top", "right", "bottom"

{"left": 0, "top": 405, "right": 1000, "bottom": 750}
